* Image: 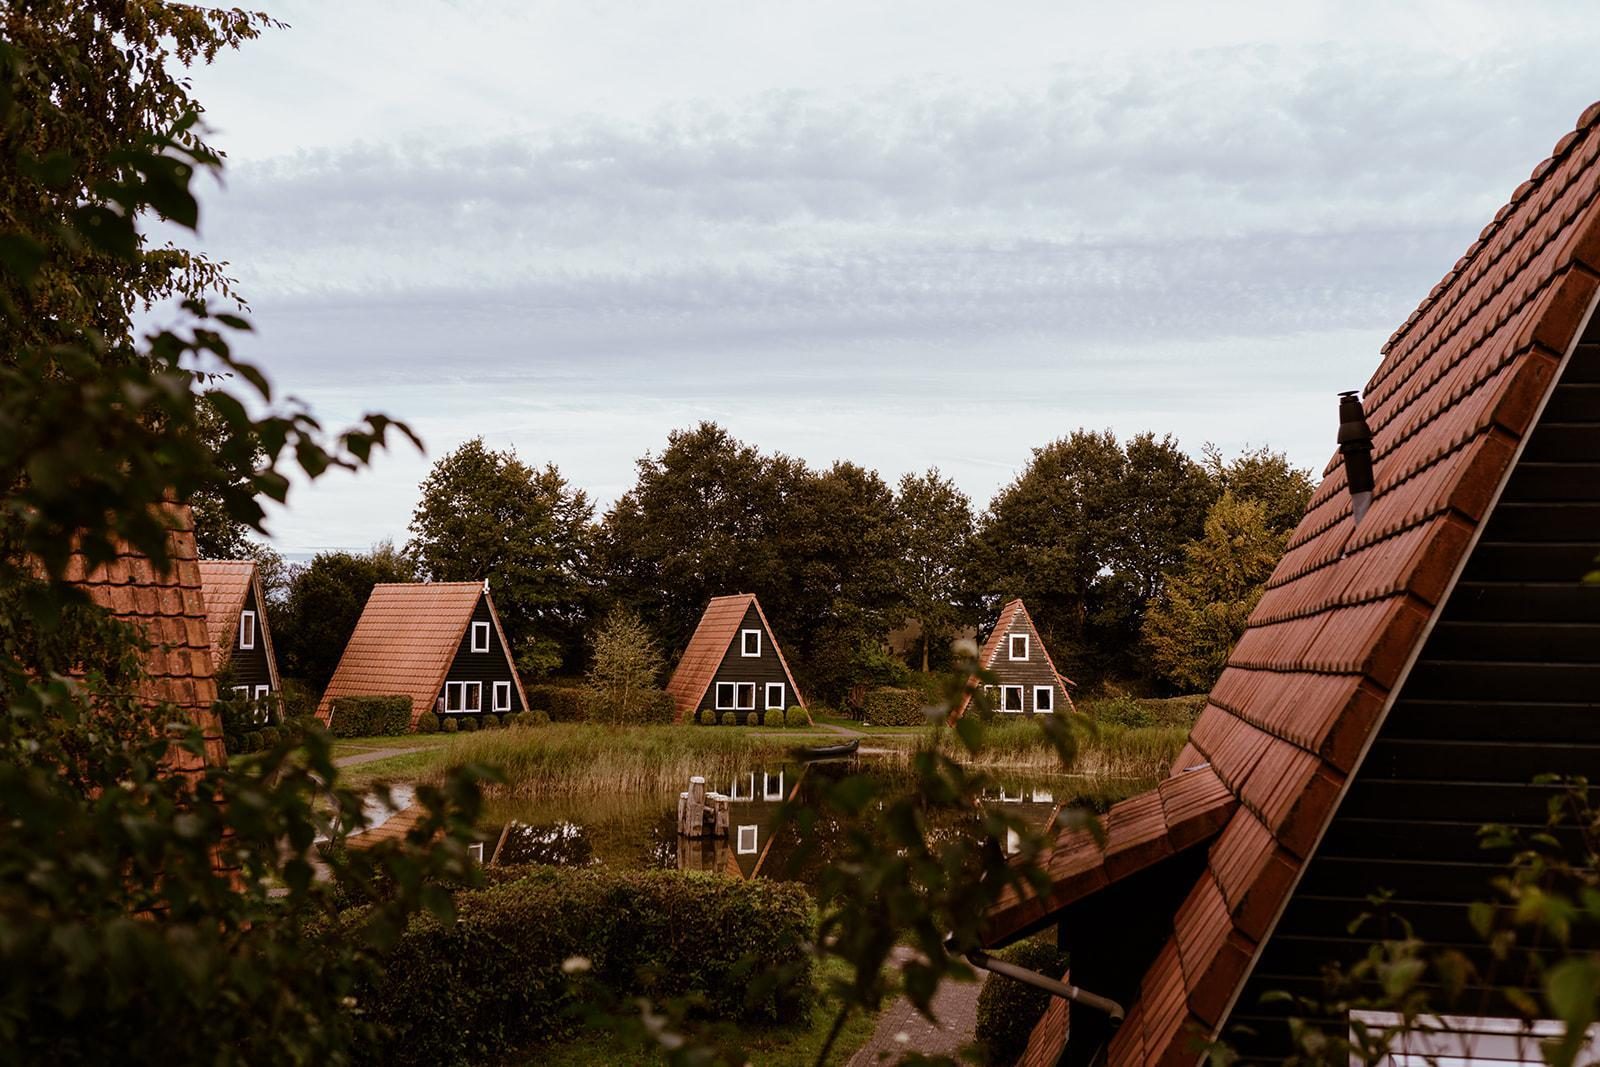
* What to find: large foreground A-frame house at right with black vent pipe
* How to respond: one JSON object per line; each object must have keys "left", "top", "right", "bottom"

{"left": 990, "top": 97, "right": 1600, "bottom": 1065}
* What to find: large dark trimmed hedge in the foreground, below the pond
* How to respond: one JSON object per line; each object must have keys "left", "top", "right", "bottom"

{"left": 334, "top": 867, "right": 813, "bottom": 1064}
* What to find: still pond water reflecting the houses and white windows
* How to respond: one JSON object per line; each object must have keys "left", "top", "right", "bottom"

{"left": 482, "top": 757, "right": 1126, "bottom": 885}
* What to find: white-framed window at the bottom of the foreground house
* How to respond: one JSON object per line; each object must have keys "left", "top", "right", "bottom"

{"left": 1350, "top": 1011, "right": 1600, "bottom": 1067}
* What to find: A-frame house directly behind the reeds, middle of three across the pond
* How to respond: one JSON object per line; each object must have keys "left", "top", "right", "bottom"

{"left": 667, "top": 593, "right": 805, "bottom": 725}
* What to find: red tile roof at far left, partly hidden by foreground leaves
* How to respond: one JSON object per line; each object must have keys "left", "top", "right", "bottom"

{"left": 67, "top": 506, "right": 227, "bottom": 774}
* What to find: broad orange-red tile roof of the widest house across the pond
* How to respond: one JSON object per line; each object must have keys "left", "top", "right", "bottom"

{"left": 305, "top": 582, "right": 528, "bottom": 723}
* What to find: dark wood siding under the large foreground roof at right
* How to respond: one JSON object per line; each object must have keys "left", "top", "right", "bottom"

{"left": 1232, "top": 334, "right": 1600, "bottom": 1059}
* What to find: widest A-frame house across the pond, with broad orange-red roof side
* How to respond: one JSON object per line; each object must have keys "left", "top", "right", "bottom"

{"left": 317, "top": 581, "right": 528, "bottom": 726}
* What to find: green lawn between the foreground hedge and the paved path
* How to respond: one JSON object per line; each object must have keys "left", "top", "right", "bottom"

{"left": 534, "top": 960, "right": 894, "bottom": 1067}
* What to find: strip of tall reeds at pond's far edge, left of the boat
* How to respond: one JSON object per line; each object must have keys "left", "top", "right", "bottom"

{"left": 434, "top": 725, "right": 795, "bottom": 797}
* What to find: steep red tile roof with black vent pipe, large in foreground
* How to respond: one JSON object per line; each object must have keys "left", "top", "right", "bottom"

{"left": 1004, "top": 97, "right": 1600, "bottom": 1064}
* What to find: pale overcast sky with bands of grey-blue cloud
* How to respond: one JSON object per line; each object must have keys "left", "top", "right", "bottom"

{"left": 175, "top": 0, "right": 1600, "bottom": 555}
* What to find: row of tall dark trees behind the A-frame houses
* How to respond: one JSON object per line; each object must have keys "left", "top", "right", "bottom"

{"left": 216, "top": 422, "right": 1312, "bottom": 702}
